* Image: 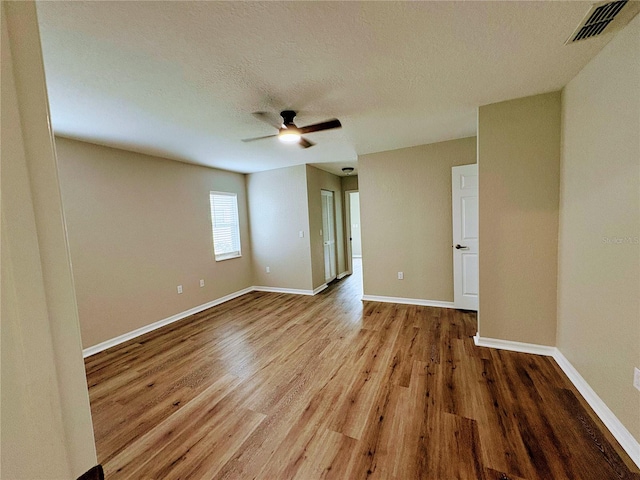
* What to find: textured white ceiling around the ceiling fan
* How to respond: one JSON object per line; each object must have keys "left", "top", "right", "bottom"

{"left": 33, "top": 1, "right": 611, "bottom": 174}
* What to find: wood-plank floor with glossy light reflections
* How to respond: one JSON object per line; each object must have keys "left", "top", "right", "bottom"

{"left": 86, "top": 262, "right": 640, "bottom": 480}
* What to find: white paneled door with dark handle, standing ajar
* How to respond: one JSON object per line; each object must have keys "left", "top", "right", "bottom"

{"left": 451, "top": 164, "right": 478, "bottom": 311}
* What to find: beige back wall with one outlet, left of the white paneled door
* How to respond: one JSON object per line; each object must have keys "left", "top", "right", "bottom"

{"left": 358, "top": 137, "right": 476, "bottom": 302}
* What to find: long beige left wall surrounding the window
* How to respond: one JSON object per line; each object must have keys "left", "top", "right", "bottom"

{"left": 56, "top": 138, "right": 252, "bottom": 347}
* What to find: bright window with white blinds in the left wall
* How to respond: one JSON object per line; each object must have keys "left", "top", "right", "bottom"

{"left": 209, "top": 192, "right": 240, "bottom": 262}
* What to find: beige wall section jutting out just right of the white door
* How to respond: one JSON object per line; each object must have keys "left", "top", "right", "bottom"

{"left": 478, "top": 92, "right": 560, "bottom": 345}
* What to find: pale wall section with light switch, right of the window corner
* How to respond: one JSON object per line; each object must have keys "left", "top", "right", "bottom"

{"left": 247, "top": 165, "right": 313, "bottom": 290}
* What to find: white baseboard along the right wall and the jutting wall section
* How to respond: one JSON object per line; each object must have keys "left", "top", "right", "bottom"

{"left": 473, "top": 335, "right": 640, "bottom": 468}
